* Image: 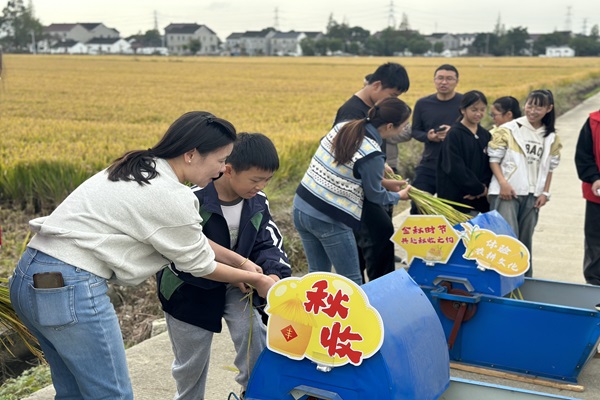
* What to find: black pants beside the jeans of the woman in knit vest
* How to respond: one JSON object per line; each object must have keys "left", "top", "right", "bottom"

{"left": 355, "top": 200, "right": 396, "bottom": 281}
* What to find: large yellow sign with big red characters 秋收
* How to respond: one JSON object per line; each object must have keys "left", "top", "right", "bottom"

{"left": 265, "top": 272, "right": 383, "bottom": 367}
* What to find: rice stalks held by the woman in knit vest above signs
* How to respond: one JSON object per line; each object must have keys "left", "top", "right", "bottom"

{"left": 385, "top": 172, "right": 473, "bottom": 226}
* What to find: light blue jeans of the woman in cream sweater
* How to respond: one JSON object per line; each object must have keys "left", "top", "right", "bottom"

{"left": 10, "top": 248, "right": 133, "bottom": 400}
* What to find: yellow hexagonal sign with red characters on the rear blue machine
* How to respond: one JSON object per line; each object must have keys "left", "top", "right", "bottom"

{"left": 392, "top": 215, "right": 459, "bottom": 265}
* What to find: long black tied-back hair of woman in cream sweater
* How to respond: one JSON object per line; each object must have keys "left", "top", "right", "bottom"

{"left": 108, "top": 111, "right": 236, "bottom": 185}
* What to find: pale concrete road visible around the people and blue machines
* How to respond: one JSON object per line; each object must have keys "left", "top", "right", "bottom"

{"left": 27, "top": 94, "right": 600, "bottom": 400}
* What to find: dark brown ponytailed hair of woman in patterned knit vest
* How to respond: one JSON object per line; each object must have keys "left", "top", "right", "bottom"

{"left": 332, "top": 97, "right": 412, "bottom": 164}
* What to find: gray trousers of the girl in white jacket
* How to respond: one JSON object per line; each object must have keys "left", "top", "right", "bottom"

{"left": 489, "top": 193, "right": 540, "bottom": 277}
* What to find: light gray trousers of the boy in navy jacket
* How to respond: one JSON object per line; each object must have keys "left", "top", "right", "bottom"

{"left": 165, "top": 285, "right": 267, "bottom": 400}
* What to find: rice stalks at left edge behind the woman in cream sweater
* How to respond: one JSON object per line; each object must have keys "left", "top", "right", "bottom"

{"left": 0, "top": 278, "right": 43, "bottom": 360}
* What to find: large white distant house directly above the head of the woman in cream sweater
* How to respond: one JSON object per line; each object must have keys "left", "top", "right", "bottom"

{"left": 165, "top": 24, "right": 219, "bottom": 55}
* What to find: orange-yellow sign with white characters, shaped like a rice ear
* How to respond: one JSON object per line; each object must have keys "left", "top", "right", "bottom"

{"left": 460, "top": 223, "right": 529, "bottom": 276}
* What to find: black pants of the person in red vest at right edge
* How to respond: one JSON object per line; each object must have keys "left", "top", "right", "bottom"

{"left": 583, "top": 201, "right": 600, "bottom": 285}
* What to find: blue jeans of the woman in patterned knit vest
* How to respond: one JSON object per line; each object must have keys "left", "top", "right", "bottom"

{"left": 294, "top": 208, "right": 362, "bottom": 285}
